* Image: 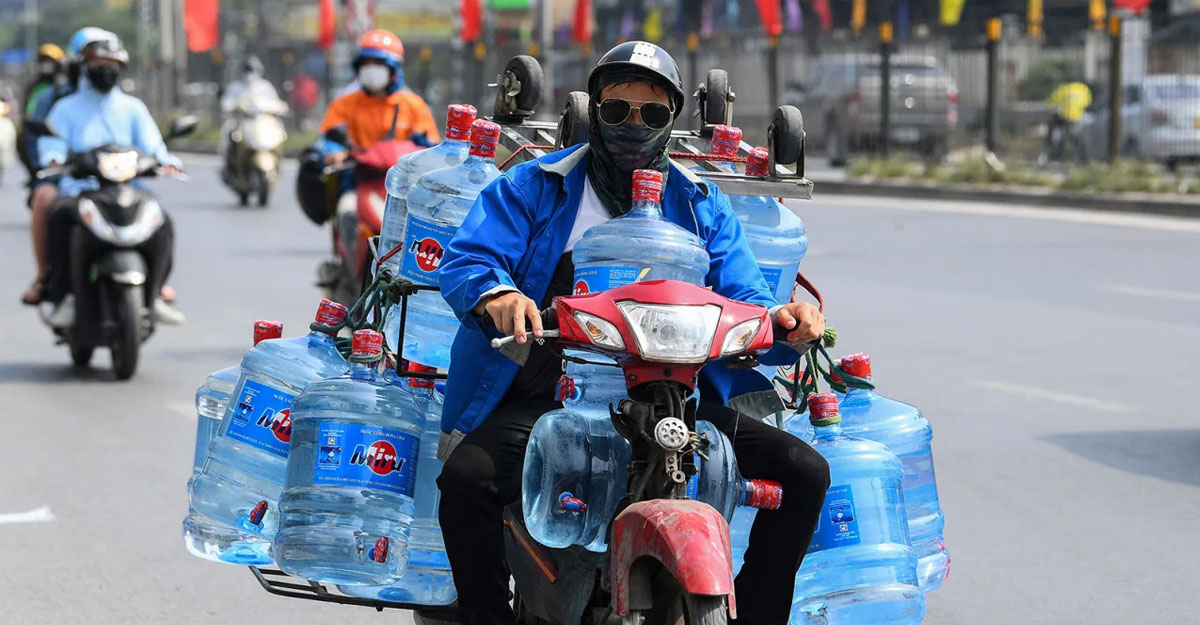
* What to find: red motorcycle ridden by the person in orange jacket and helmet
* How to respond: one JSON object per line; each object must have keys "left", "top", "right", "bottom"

{"left": 317, "top": 127, "right": 421, "bottom": 306}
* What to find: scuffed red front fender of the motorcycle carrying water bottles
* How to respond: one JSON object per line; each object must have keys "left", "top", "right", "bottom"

{"left": 608, "top": 499, "right": 738, "bottom": 619}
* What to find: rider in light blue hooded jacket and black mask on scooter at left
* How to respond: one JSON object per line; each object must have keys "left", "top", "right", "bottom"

{"left": 38, "top": 35, "right": 184, "bottom": 327}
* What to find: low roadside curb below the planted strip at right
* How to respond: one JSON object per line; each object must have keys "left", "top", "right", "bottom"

{"left": 812, "top": 178, "right": 1200, "bottom": 218}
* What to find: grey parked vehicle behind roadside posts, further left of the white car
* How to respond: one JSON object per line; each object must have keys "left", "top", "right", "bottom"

{"left": 786, "top": 54, "right": 959, "bottom": 166}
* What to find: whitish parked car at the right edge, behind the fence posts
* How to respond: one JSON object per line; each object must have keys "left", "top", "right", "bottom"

{"left": 1076, "top": 74, "right": 1200, "bottom": 169}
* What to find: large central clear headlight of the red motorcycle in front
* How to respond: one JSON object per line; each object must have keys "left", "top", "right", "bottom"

{"left": 617, "top": 301, "right": 721, "bottom": 363}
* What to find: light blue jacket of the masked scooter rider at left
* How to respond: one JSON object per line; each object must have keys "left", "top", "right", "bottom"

{"left": 37, "top": 78, "right": 180, "bottom": 196}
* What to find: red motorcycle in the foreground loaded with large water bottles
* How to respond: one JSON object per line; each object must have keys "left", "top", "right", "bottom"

{"left": 492, "top": 281, "right": 781, "bottom": 625}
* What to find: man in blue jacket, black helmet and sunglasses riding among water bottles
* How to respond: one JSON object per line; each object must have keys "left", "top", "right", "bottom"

{"left": 438, "top": 42, "right": 829, "bottom": 625}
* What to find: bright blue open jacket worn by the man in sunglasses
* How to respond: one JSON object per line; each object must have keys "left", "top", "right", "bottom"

{"left": 438, "top": 145, "right": 798, "bottom": 456}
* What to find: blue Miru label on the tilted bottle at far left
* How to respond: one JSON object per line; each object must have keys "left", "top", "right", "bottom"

{"left": 224, "top": 379, "right": 295, "bottom": 458}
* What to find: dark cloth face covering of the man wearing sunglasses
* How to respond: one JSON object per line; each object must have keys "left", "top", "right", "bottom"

{"left": 588, "top": 106, "right": 671, "bottom": 217}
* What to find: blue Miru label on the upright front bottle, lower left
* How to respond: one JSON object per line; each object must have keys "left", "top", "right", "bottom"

{"left": 312, "top": 422, "right": 420, "bottom": 497}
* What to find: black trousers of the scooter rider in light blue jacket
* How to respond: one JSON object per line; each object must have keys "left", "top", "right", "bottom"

{"left": 46, "top": 197, "right": 175, "bottom": 305}
